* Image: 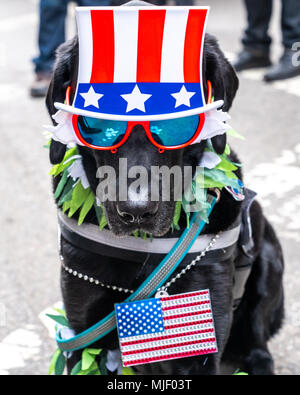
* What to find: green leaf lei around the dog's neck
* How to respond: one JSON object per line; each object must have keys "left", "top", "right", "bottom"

{"left": 50, "top": 138, "right": 242, "bottom": 235}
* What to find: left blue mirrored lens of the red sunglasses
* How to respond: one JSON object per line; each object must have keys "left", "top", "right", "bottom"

{"left": 77, "top": 116, "right": 127, "bottom": 147}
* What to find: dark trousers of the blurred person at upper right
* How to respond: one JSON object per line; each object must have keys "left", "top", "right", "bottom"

{"left": 242, "top": 0, "right": 300, "bottom": 52}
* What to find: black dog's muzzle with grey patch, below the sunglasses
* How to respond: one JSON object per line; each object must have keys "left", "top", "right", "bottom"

{"left": 93, "top": 126, "right": 184, "bottom": 237}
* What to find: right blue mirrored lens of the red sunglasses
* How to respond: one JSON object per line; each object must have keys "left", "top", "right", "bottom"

{"left": 150, "top": 115, "right": 199, "bottom": 147}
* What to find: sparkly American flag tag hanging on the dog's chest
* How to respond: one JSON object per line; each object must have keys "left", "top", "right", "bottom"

{"left": 115, "top": 290, "right": 218, "bottom": 367}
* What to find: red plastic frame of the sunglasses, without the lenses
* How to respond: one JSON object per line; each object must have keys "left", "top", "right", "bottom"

{"left": 66, "top": 81, "right": 212, "bottom": 153}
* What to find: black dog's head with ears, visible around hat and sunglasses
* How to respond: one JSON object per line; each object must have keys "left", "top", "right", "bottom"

{"left": 46, "top": 2, "right": 238, "bottom": 236}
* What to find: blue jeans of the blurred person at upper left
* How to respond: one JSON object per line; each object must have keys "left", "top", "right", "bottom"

{"left": 33, "top": 0, "right": 111, "bottom": 72}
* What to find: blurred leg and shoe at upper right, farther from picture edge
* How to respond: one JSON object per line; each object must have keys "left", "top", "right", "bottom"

{"left": 234, "top": 0, "right": 273, "bottom": 71}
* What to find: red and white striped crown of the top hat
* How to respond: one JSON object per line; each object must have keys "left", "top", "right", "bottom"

{"left": 78, "top": 7, "right": 208, "bottom": 83}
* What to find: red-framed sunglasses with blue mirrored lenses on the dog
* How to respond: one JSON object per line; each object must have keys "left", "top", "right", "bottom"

{"left": 66, "top": 81, "right": 212, "bottom": 153}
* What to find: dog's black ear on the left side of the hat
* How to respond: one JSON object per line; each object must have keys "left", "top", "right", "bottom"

{"left": 46, "top": 37, "right": 78, "bottom": 164}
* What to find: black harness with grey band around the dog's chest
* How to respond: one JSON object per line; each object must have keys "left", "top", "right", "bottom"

{"left": 58, "top": 189, "right": 256, "bottom": 310}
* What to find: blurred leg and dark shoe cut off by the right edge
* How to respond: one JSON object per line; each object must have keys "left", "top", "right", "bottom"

{"left": 264, "top": 0, "right": 300, "bottom": 81}
